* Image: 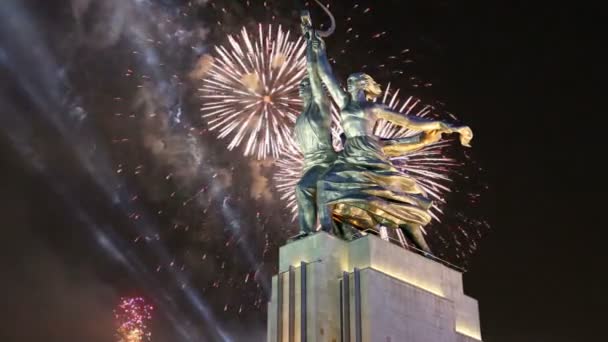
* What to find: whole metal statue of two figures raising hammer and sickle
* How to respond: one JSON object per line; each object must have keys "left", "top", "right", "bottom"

{"left": 295, "top": 2, "right": 473, "bottom": 253}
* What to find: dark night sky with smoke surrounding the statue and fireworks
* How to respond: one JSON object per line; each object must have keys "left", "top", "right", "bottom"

{"left": 0, "top": 0, "right": 606, "bottom": 342}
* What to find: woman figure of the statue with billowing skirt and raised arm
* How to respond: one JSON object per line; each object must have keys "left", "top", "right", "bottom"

{"left": 308, "top": 35, "right": 473, "bottom": 252}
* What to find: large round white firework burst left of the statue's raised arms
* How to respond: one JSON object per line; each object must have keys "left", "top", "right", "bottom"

{"left": 199, "top": 24, "right": 306, "bottom": 159}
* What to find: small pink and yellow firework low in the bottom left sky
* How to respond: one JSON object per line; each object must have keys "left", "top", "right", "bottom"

{"left": 114, "top": 297, "right": 154, "bottom": 342}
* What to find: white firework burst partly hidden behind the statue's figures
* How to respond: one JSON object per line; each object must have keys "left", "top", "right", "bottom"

{"left": 275, "top": 84, "right": 460, "bottom": 221}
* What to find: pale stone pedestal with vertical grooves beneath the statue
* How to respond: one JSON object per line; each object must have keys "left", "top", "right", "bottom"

{"left": 267, "top": 232, "right": 481, "bottom": 342}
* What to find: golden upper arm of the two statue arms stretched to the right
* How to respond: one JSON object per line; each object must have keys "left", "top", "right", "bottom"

{"left": 375, "top": 106, "right": 473, "bottom": 146}
